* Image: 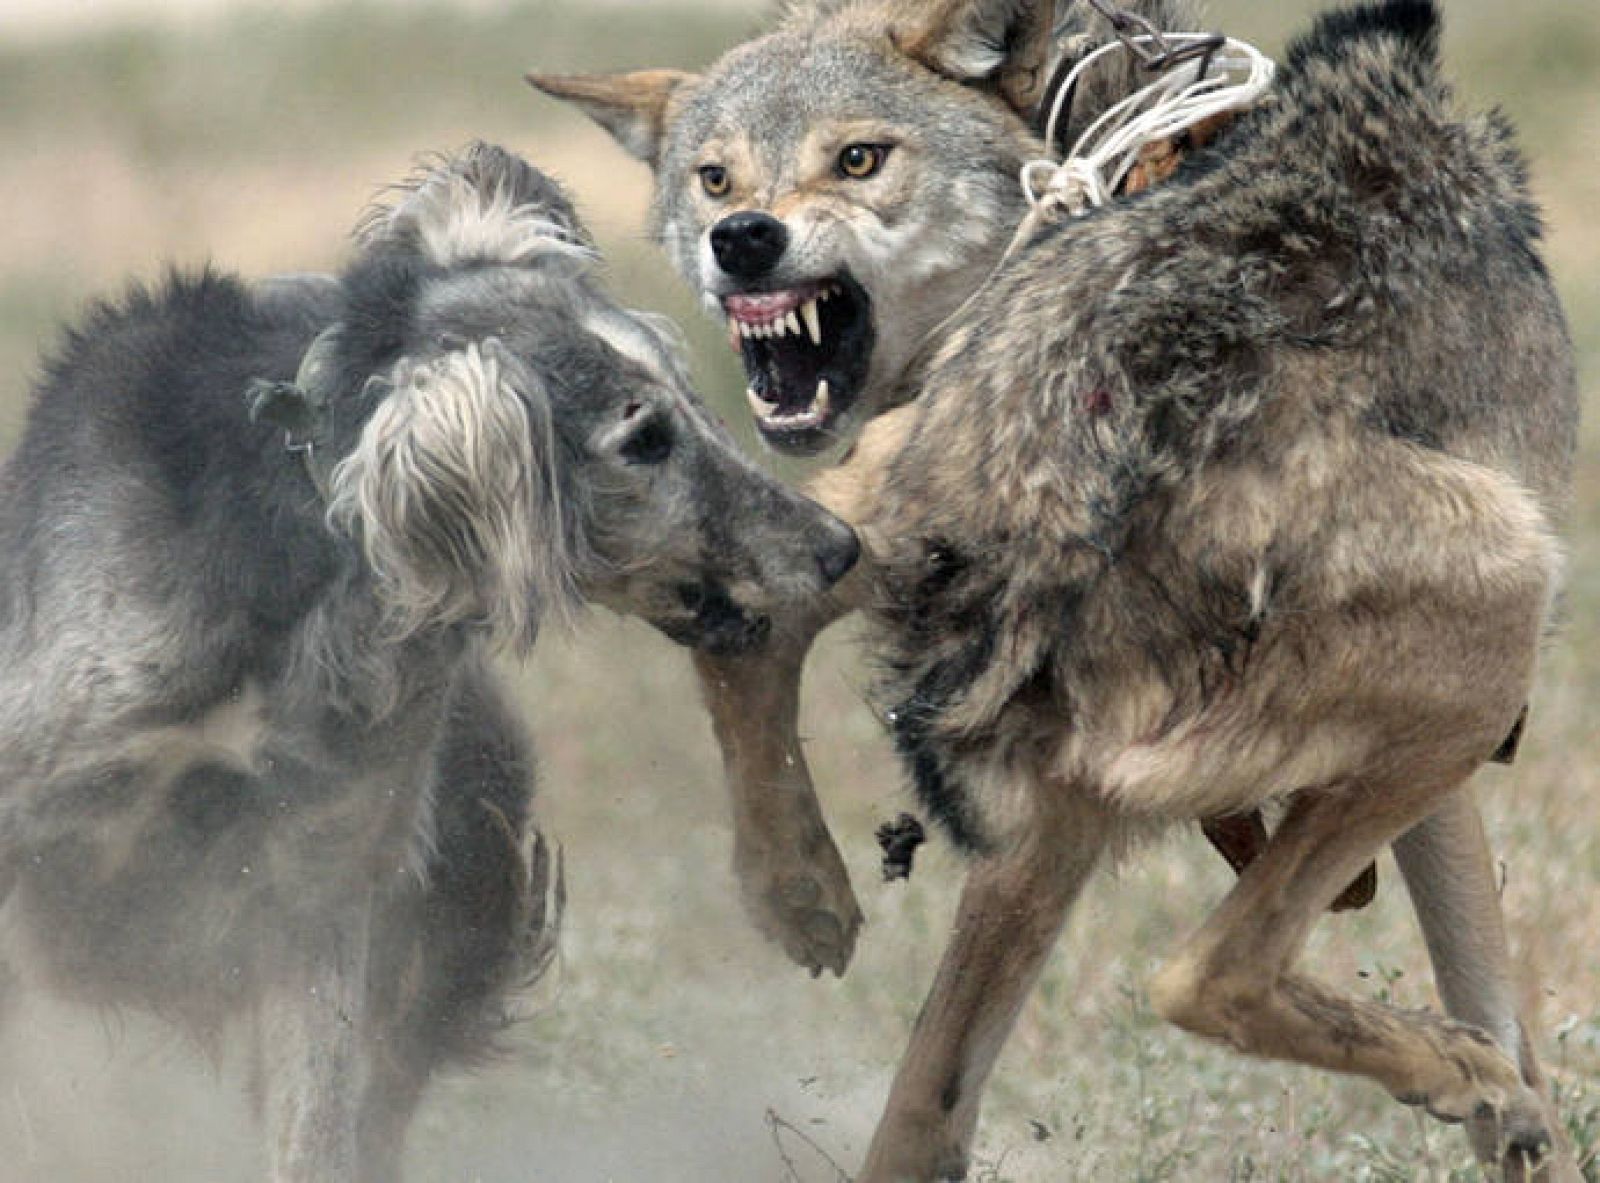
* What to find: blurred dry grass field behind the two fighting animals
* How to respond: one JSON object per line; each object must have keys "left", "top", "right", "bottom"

{"left": 0, "top": 0, "right": 1600, "bottom": 1183}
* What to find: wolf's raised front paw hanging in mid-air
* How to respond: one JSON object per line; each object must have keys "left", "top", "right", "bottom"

{"left": 734, "top": 834, "right": 862, "bottom": 978}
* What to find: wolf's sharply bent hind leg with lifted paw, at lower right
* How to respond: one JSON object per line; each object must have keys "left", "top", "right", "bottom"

{"left": 1150, "top": 768, "right": 1550, "bottom": 1180}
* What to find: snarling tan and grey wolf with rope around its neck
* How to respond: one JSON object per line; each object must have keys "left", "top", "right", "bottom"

{"left": 536, "top": 0, "right": 1578, "bottom": 1183}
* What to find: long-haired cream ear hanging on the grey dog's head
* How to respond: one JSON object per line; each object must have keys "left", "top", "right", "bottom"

{"left": 328, "top": 339, "right": 578, "bottom": 645}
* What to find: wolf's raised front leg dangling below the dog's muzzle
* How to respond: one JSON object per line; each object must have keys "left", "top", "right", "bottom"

{"left": 694, "top": 629, "right": 861, "bottom": 976}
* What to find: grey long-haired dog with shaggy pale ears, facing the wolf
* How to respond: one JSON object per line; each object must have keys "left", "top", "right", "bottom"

{"left": 0, "top": 146, "right": 858, "bottom": 1183}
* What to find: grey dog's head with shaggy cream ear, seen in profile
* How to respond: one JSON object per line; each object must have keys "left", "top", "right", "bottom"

{"left": 272, "top": 146, "right": 858, "bottom": 650}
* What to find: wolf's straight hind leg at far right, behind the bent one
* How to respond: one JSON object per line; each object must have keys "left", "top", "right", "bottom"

{"left": 1394, "top": 789, "right": 1582, "bottom": 1183}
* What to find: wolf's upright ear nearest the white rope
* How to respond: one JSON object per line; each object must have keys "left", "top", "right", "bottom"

{"left": 891, "top": 0, "right": 1056, "bottom": 114}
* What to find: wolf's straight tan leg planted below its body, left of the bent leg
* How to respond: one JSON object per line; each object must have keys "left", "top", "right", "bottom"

{"left": 858, "top": 802, "right": 1109, "bottom": 1183}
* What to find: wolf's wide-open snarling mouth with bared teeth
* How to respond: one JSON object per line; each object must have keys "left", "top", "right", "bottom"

{"left": 722, "top": 274, "right": 872, "bottom": 453}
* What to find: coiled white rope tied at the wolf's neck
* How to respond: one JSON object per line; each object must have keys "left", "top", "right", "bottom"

{"left": 1021, "top": 34, "right": 1277, "bottom": 221}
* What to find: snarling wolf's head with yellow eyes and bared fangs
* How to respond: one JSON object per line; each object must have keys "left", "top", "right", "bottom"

{"left": 530, "top": 0, "right": 1053, "bottom": 453}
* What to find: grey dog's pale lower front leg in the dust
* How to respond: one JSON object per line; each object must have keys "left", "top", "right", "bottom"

{"left": 256, "top": 925, "right": 371, "bottom": 1183}
